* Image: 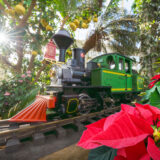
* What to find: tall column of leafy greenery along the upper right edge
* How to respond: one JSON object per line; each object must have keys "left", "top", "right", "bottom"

{"left": 133, "top": 0, "right": 160, "bottom": 76}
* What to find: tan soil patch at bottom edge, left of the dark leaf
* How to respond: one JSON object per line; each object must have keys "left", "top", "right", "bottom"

{"left": 39, "top": 144, "right": 89, "bottom": 160}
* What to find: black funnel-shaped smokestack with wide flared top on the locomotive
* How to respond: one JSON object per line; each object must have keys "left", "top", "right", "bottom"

{"left": 52, "top": 29, "right": 73, "bottom": 62}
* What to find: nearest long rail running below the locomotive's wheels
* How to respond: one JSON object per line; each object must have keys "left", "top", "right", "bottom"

{"left": 0, "top": 106, "right": 120, "bottom": 143}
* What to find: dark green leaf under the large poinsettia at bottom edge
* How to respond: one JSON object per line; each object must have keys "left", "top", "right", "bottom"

{"left": 88, "top": 146, "right": 117, "bottom": 160}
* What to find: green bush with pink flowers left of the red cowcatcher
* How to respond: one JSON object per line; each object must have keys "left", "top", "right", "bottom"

{"left": 0, "top": 71, "right": 39, "bottom": 118}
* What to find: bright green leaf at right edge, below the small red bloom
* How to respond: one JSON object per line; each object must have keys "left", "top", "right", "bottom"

{"left": 150, "top": 89, "right": 160, "bottom": 107}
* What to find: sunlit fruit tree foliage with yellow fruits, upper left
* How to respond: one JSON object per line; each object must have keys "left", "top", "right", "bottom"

{"left": 0, "top": 0, "right": 107, "bottom": 83}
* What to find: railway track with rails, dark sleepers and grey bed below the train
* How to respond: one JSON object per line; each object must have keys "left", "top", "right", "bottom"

{"left": 0, "top": 106, "right": 120, "bottom": 160}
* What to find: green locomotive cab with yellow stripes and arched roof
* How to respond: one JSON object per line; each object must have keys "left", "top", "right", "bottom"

{"left": 88, "top": 53, "right": 144, "bottom": 100}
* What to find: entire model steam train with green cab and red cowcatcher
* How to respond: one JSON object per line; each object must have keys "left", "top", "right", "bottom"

{"left": 10, "top": 30, "right": 144, "bottom": 122}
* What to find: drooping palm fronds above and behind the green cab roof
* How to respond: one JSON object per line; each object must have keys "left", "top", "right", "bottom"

{"left": 84, "top": 1, "right": 138, "bottom": 55}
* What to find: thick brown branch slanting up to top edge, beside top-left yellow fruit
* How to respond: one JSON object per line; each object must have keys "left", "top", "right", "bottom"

{"left": 15, "top": 0, "right": 36, "bottom": 29}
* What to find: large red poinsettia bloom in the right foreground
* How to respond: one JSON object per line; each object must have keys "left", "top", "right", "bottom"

{"left": 78, "top": 104, "right": 160, "bottom": 160}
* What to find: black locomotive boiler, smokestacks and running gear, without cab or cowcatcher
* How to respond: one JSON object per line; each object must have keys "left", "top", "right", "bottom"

{"left": 47, "top": 30, "right": 110, "bottom": 114}
